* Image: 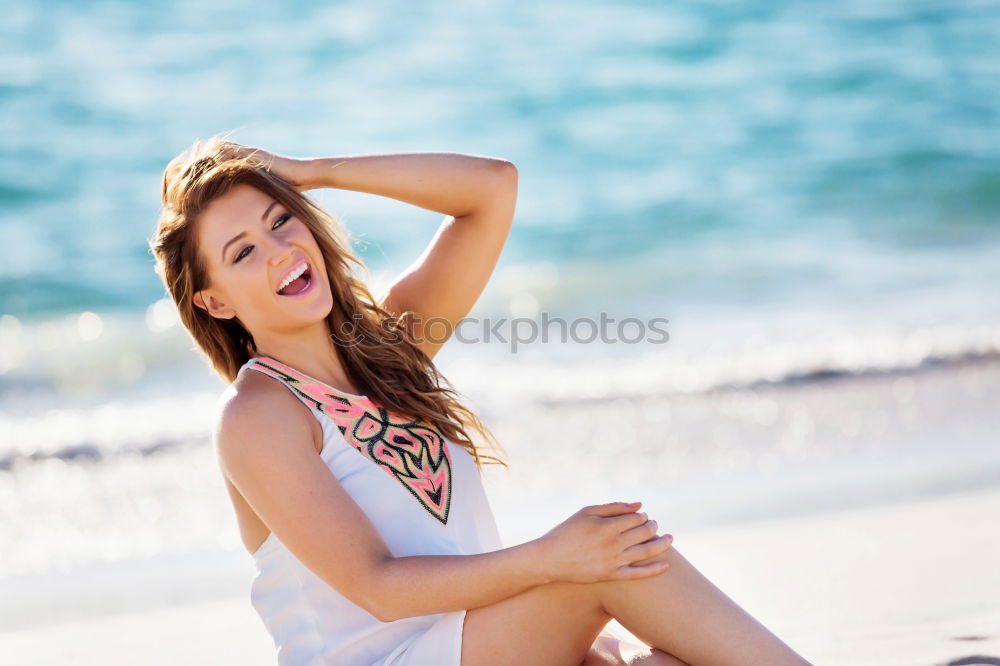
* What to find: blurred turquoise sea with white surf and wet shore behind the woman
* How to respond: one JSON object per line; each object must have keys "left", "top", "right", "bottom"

{"left": 0, "top": 0, "right": 1000, "bottom": 660}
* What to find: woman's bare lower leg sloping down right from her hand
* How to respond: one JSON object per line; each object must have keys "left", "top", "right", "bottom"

{"left": 592, "top": 546, "right": 811, "bottom": 666}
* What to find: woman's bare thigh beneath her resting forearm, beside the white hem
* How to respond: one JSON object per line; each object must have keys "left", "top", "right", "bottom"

{"left": 462, "top": 582, "right": 611, "bottom": 666}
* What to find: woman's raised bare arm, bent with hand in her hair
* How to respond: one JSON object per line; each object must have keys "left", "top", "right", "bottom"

{"left": 219, "top": 144, "right": 518, "bottom": 358}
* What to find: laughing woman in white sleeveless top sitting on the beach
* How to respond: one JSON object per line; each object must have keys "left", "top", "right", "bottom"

{"left": 150, "top": 132, "right": 808, "bottom": 666}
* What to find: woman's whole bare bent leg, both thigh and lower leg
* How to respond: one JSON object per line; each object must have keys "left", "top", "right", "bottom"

{"left": 462, "top": 546, "right": 812, "bottom": 666}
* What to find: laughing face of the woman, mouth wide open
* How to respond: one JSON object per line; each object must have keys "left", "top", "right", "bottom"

{"left": 194, "top": 183, "right": 333, "bottom": 341}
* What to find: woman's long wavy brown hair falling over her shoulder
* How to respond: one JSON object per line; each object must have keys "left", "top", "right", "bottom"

{"left": 149, "top": 135, "right": 507, "bottom": 471}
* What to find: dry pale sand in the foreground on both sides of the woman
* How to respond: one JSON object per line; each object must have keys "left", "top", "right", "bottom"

{"left": 0, "top": 482, "right": 1000, "bottom": 666}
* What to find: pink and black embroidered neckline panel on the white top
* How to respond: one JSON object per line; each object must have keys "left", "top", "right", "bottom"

{"left": 248, "top": 357, "right": 452, "bottom": 524}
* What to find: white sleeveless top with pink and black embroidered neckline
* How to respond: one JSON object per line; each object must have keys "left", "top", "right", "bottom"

{"left": 231, "top": 356, "right": 503, "bottom": 666}
